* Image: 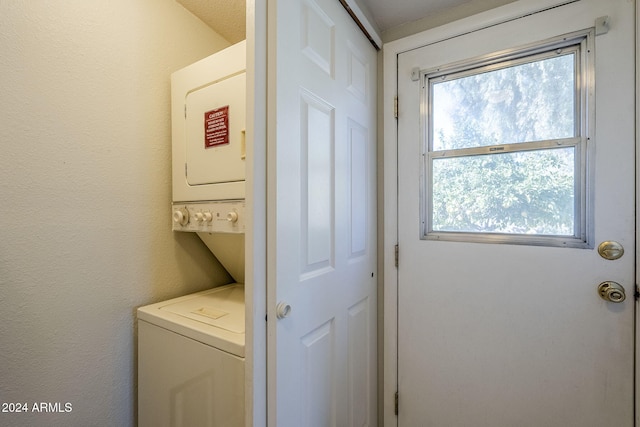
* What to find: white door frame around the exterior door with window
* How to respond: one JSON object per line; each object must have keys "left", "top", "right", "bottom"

{"left": 381, "top": 0, "right": 640, "bottom": 427}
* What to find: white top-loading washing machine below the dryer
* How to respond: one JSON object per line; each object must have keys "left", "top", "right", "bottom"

{"left": 138, "top": 283, "right": 245, "bottom": 427}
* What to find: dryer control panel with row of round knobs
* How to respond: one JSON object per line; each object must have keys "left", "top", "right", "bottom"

{"left": 172, "top": 200, "right": 245, "bottom": 233}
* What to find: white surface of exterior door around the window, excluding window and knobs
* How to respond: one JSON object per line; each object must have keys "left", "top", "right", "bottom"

{"left": 398, "top": 0, "right": 635, "bottom": 427}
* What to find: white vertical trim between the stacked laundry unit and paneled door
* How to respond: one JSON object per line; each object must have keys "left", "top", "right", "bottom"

{"left": 244, "top": 0, "right": 267, "bottom": 427}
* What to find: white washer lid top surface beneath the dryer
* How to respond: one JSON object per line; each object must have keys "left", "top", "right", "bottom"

{"left": 158, "top": 285, "right": 245, "bottom": 334}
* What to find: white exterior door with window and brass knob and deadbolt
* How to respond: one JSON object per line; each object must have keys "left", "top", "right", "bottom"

{"left": 398, "top": 0, "right": 635, "bottom": 427}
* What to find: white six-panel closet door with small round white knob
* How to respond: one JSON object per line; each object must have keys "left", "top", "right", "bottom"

{"left": 268, "top": 0, "right": 377, "bottom": 427}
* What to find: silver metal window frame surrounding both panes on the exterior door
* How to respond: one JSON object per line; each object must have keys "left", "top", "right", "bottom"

{"left": 420, "top": 29, "right": 595, "bottom": 248}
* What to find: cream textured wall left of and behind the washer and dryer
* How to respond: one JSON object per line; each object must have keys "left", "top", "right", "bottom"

{"left": 0, "top": 0, "right": 229, "bottom": 426}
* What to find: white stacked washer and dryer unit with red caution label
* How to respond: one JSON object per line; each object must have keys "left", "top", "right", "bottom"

{"left": 138, "top": 42, "right": 246, "bottom": 427}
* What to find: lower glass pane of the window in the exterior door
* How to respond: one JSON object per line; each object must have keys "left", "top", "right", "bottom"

{"left": 431, "top": 147, "right": 575, "bottom": 236}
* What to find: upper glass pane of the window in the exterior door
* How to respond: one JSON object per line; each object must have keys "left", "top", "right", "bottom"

{"left": 431, "top": 53, "right": 576, "bottom": 151}
